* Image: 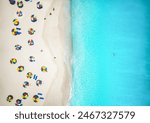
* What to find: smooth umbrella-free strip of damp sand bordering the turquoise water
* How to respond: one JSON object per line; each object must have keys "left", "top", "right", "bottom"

{"left": 44, "top": 0, "right": 72, "bottom": 105}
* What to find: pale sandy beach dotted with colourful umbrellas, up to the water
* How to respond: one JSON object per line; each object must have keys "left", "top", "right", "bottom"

{"left": 0, "top": 0, "right": 72, "bottom": 106}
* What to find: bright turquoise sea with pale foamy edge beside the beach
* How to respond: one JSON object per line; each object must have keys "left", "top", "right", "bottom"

{"left": 70, "top": 0, "right": 150, "bottom": 106}
